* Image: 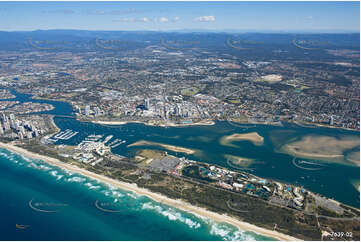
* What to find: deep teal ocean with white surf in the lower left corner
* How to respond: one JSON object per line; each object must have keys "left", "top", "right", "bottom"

{"left": 0, "top": 149, "right": 273, "bottom": 240}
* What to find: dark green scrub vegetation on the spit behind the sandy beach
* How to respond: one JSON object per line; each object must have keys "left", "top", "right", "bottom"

{"left": 103, "top": 151, "right": 359, "bottom": 240}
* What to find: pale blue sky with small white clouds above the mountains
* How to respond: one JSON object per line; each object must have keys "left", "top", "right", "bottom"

{"left": 0, "top": 2, "right": 360, "bottom": 32}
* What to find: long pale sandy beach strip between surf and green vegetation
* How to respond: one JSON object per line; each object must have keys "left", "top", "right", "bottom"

{"left": 0, "top": 142, "right": 300, "bottom": 241}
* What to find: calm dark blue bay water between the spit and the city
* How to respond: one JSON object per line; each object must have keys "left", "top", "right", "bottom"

{"left": 55, "top": 118, "right": 360, "bottom": 207}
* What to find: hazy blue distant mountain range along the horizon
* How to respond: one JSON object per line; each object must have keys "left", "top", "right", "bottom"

{"left": 0, "top": 29, "right": 360, "bottom": 51}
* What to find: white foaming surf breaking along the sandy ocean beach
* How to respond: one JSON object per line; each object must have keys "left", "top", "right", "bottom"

{"left": 0, "top": 149, "right": 268, "bottom": 241}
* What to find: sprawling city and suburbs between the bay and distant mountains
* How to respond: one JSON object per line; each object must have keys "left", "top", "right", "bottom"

{"left": 0, "top": 34, "right": 360, "bottom": 129}
